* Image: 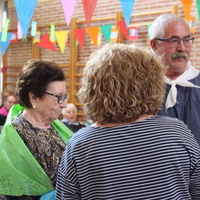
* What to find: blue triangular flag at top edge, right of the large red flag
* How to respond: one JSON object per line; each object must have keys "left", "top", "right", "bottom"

{"left": 120, "top": 0, "right": 135, "bottom": 27}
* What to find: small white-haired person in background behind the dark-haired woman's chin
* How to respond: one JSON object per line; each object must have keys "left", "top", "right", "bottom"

{"left": 61, "top": 103, "right": 85, "bottom": 133}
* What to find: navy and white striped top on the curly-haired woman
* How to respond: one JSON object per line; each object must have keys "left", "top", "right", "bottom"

{"left": 56, "top": 116, "right": 200, "bottom": 200}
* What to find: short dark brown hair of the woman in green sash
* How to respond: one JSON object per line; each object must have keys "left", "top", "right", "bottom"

{"left": 16, "top": 59, "right": 65, "bottom": 108}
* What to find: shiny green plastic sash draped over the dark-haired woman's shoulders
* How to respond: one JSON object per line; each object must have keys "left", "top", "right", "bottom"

{"left": 0, "top": 104, "right": 73, "bottom": 196}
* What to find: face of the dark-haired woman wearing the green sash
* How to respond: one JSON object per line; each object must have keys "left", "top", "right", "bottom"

{"left": 36, "top": 81, "right": 67, "bottom": 122}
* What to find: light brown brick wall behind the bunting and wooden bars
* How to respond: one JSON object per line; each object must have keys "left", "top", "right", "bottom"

{"left": 4, "top": 0, "right": 200, "bottom": 120}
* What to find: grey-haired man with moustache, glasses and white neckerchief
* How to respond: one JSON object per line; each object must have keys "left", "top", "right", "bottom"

{"left": 150, "top": 13, "right": 200, "bottom": 144}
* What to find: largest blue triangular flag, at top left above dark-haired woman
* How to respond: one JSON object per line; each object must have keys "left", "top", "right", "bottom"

{"left": 14, "top": 0, "right": 38, "bottom": 38}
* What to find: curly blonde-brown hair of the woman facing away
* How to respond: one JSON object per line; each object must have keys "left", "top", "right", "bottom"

{"left": 78, "top": 43, "right": 165, "bottom": 124}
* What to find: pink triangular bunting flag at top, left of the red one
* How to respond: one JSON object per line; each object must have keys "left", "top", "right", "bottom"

{"left": 61, "top": 0, "right": 76, "bottom": 26}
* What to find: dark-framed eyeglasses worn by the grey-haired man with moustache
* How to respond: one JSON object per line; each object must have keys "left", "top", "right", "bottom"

{"left": 154, "top": 37, "right": 195, "bottom": 47}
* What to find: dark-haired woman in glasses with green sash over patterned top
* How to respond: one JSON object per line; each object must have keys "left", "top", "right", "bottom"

{"left": 0, "top": 59, "right": 73, "bottom": 200}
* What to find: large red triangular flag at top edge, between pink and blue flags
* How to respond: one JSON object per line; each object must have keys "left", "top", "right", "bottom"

{"left": 82, "top": 0, "right": 97, "bottom": 26}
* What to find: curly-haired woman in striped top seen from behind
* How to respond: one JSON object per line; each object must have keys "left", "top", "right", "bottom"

{"left": 56, "top": 43, "right": 200, "bottom": 200}
